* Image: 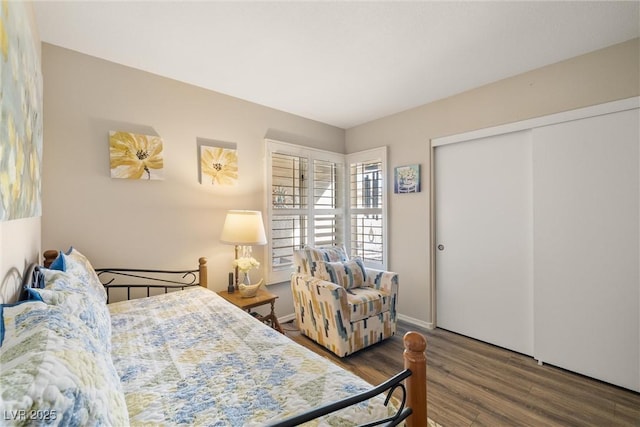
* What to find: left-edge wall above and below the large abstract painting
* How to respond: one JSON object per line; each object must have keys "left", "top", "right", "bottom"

{"left": 0, "top": 2, "right": 41, "bottom": 302}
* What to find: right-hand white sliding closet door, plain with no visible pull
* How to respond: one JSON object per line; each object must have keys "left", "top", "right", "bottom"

{"left": 533, "top": 109, "right": 640, "bottom": 391}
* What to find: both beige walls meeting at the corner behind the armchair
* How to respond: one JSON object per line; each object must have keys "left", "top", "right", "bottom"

{"left": 41, "top": 39, "right": 640, "bottom": 324}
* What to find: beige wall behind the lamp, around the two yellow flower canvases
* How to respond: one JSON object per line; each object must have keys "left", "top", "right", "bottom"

{"left": 42, "top": 44, "right": 344, "bottom": 316}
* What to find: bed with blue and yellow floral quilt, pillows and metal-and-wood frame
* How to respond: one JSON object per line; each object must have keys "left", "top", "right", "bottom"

{"left": 0, "top": 249, "right": 427, "bottom": 426}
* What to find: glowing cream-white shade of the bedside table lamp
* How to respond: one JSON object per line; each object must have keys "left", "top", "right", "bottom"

{"left": 220, "top": 210, "right": 267, "bottom": 246}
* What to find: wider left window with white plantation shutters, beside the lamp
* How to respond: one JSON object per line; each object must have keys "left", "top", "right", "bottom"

{"left": 267, "top": 140, "right": 345, "bottom": 283}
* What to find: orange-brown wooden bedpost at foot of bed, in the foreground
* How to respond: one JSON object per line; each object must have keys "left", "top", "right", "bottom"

{"left": 403, "top": 331, "right": 427, "bottom": 427}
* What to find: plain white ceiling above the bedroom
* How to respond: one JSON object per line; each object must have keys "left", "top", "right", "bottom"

{"left": 34, "top": 1, "right": 640, "bottom": 128}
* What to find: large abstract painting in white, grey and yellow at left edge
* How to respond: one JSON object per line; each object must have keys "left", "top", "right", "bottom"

{"left": 0, "top": 1, "right": 42, "bottom": 221}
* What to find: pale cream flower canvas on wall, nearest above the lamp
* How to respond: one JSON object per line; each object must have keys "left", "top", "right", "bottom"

{"left": 198, "top": 140, "right": 238, "bottom": 186}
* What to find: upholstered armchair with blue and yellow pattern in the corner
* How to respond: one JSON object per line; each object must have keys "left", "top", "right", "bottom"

{"left": 291, "top": 247, "right": 398, "bottom": 357}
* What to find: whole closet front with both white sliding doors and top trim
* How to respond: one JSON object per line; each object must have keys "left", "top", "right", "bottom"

{"left": 431, "top": 98, "right": 640, "bottom": 391}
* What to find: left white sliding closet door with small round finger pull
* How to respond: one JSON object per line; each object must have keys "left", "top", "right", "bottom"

{"left": 434, "top": 130, "right": 533, "bottom": 355}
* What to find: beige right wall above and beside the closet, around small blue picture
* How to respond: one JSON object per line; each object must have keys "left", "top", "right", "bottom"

{"left": 345, "top": 39, "right": 640, "bottom": 323}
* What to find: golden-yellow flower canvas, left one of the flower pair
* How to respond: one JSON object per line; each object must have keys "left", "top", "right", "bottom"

{"left": 109, "top": 131, "right": 164, "bottom": 180}
